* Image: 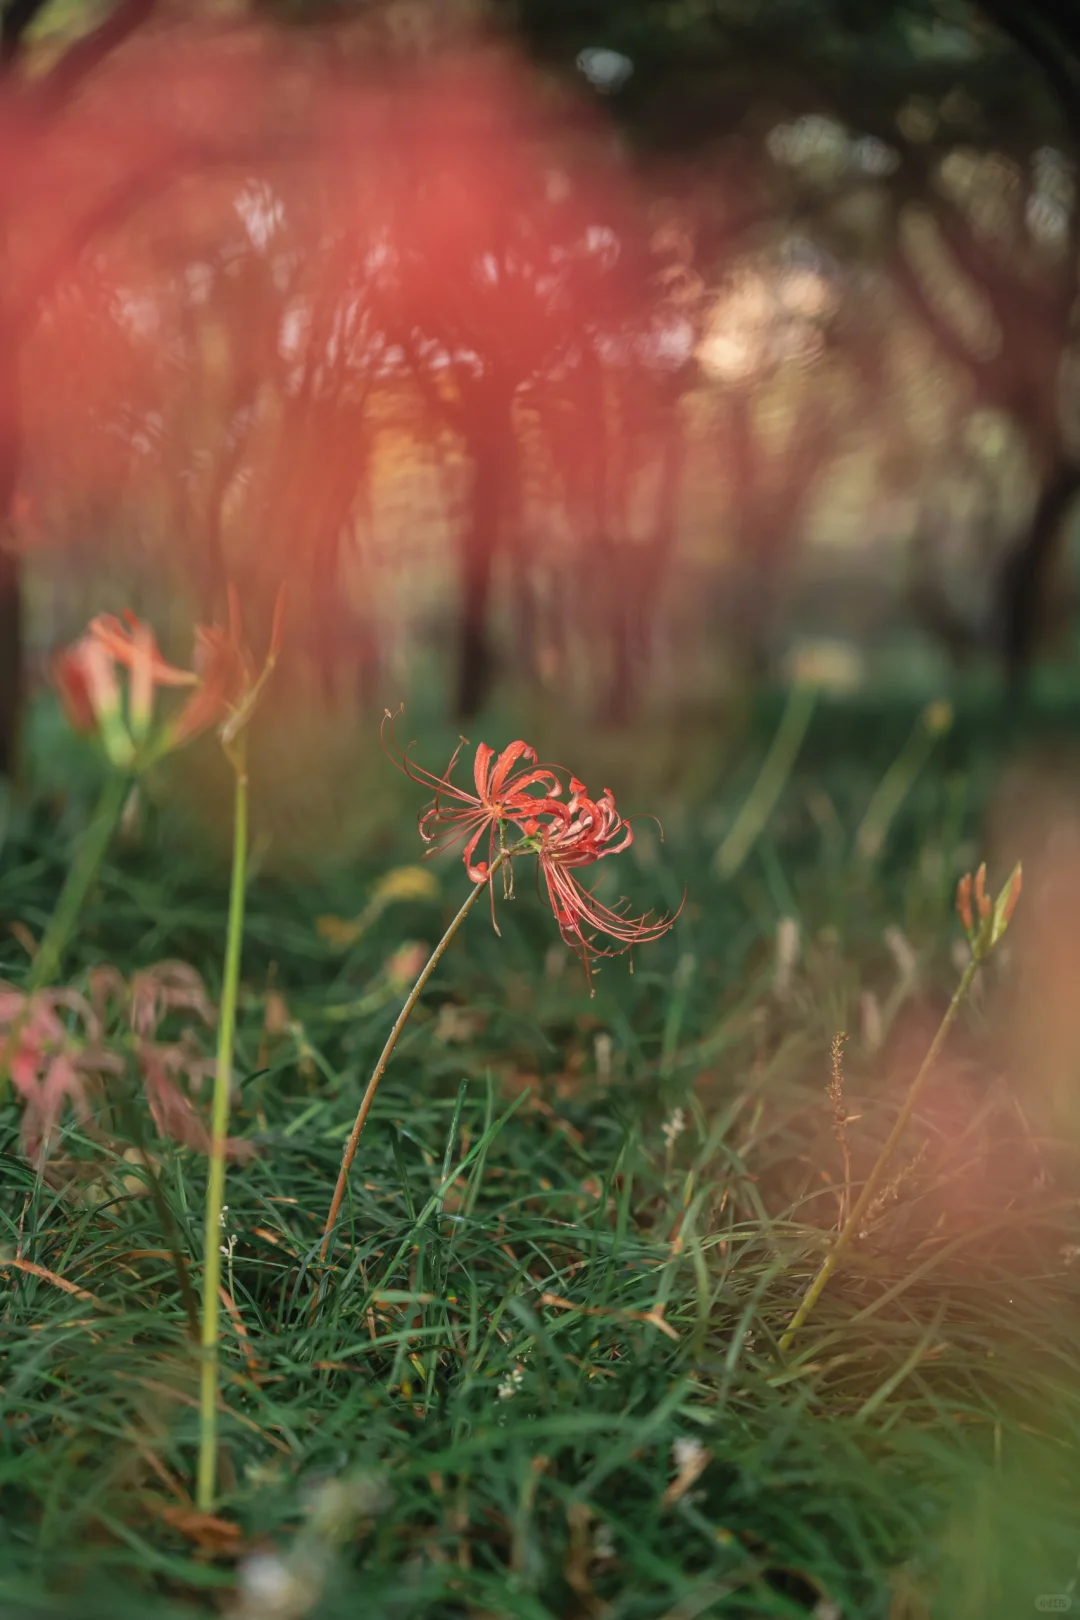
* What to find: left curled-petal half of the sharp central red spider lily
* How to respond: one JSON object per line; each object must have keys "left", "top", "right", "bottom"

{"left": 381, "top": 710, "right": 567, "bottom": 883}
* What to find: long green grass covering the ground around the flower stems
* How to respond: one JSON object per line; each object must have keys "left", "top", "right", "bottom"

{"left": 0, "top": 690, "right": 1080, "bottom": 1620}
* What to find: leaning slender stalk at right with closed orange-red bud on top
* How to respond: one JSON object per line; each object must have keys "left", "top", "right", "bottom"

{"left": 780, "top": 865, "right": 1022, "bottom": 1354}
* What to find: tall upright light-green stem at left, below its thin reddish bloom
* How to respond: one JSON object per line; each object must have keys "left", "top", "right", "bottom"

{"left": 196, "top": 735, "right": 248, "bottom": 1513}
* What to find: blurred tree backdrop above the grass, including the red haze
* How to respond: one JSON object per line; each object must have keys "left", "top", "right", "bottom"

{"left": 0, "top": 0, "right": 1080, "bottom": 790}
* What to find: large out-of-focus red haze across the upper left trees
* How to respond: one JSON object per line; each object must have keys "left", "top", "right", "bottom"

{"left": 0, "top": 5, "right": 677, "bottom": 711}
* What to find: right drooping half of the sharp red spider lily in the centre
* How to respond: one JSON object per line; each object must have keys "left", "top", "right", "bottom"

{"left": 534, "top": 776, "right": 682, "bottom": 988}
